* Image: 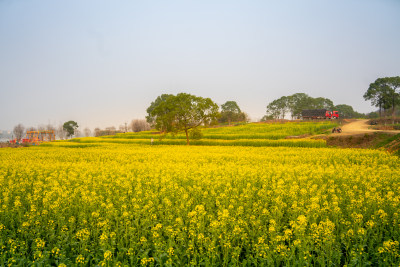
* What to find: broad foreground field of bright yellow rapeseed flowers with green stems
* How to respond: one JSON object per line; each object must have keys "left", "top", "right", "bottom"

{"left": 0, "top": 142, "right": 400, "bottom": 266}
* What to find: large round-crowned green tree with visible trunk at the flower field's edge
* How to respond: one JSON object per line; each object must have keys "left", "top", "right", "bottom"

{"left": 147, "top": 93, "right": 219, "bottom": 145}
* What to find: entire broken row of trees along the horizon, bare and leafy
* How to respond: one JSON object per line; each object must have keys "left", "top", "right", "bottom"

{"left": 14, "top": 77, "right": 400, "bottom": 144}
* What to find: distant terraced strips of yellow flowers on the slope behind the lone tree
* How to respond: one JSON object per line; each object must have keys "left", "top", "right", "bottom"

{"left": 70, "top": 121, "right": 338, "bottom": 147}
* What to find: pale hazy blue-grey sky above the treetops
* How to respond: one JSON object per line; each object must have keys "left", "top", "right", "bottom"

{"left": 0, "top": 0, "right": 400, "bottom": 130}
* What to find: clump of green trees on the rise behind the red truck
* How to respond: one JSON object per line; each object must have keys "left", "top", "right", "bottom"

{"left": 261, "top": 93, "right": 365, "bottom": 121}
